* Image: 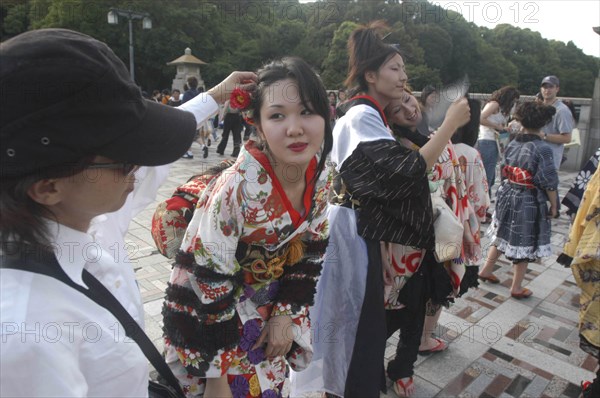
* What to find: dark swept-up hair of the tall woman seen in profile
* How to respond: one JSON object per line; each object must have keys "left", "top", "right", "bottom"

{"left": 344, "top": 20, "right": 400, "bottom": 97}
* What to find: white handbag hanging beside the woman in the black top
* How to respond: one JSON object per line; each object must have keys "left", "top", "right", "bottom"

{"left": 431, "top": 190, "right": 464, "bottom": 263}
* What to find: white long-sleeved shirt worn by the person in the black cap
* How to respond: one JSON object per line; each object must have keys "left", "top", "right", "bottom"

{"left": 0, "top": 94, "right": 218, "bottom": 397}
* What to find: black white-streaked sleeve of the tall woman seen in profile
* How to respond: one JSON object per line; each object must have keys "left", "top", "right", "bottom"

{"left": 340, "top": 140, "right": 435, "bottom": 250}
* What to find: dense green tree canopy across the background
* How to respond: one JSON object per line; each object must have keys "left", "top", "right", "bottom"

{"left": 0, "top": 0, "right": 600, "bottom": 97}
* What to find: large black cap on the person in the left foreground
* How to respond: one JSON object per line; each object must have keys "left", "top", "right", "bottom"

{"left": 0, "top": 29, "right": 196, "bottom": 178}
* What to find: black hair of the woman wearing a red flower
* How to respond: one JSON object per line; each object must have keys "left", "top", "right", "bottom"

{"left": 251, "top": 57, "right": 333, "bottom": 179}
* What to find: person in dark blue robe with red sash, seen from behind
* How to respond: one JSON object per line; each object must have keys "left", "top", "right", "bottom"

{"left": 479, "top": 102, "right": 558, "bottom": 299}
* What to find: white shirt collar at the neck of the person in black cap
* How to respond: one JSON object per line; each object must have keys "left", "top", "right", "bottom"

{"left": 47, "top": 220, "right": 93, "bottom": 287}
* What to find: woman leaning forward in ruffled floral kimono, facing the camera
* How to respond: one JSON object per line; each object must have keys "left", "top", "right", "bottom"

{"left": 163, "top": 58, "right": 332, "bottom": 397}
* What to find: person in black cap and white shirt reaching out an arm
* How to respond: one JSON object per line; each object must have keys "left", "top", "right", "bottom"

{"left": 0, "top": 29, "right": 255, "bottom": 397}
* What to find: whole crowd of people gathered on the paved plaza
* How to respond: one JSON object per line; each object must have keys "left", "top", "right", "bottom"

{"left": 0, "top": 21, "right": 600, "bottom": 398}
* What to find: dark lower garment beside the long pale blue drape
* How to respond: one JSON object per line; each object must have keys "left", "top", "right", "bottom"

{"left": 340, "top": 240, "right": 386, "bottom": 398}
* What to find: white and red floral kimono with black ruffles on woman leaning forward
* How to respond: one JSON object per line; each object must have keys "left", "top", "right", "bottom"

{"left": 163, "top": 141, "right": 331, "bottom": 397}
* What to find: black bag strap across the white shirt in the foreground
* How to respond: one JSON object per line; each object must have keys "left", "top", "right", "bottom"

{"left": 0, "top": 254, "right": 185, "bottom": 397}
